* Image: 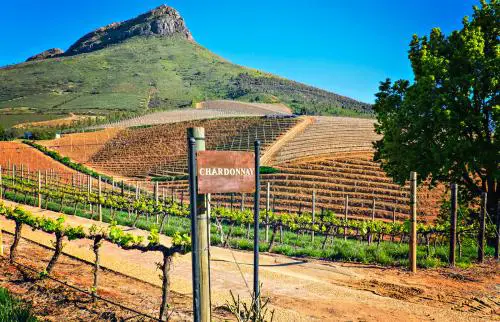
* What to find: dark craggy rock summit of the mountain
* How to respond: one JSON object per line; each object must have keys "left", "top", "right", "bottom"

{"left": 65, "top": 5, "right": 193, "bottom": 56}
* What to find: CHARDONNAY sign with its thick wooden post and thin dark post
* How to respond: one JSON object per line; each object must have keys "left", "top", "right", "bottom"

{"left": 187, "top": 128, "right": 260, "bottom": 322}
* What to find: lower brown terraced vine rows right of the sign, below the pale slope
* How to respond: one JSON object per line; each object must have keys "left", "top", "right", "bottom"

{"left": 155, "top": 153, "right": 444, "bottom": 222}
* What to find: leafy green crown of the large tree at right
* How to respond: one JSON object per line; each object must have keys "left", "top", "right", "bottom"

{"left": 374, "top": 0, "right": 500, "bottom": 213}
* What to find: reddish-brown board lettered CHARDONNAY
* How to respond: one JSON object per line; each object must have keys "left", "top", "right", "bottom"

{"left": 196, "top": 151, "right": 255, "bottom": 194}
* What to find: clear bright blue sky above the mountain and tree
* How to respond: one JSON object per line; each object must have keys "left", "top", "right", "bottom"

{"left": 0, "top": 0, "right": 479, "bottom": 102}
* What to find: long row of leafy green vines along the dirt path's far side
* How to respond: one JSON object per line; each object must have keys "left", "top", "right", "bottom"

{"left": 2, "top": 167, "right": 495, "bottom": 266}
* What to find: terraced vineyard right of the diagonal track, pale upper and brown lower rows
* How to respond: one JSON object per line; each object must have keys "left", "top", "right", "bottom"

{"left": 152, "top": 117, "right": 444, "bottom": 221}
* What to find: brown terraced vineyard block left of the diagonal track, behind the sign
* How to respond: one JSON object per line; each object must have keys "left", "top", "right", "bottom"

{"left": 89, "top": 117, "right": 297, "bottom": 177}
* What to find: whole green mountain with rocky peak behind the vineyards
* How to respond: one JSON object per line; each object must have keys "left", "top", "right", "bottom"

{"left": 0, "top": 6, "right": 371, "bottom": 122}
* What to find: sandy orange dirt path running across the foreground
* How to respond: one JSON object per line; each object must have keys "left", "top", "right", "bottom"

{"left": 1, "top": 202, "right": 500, "bottom": 321}
